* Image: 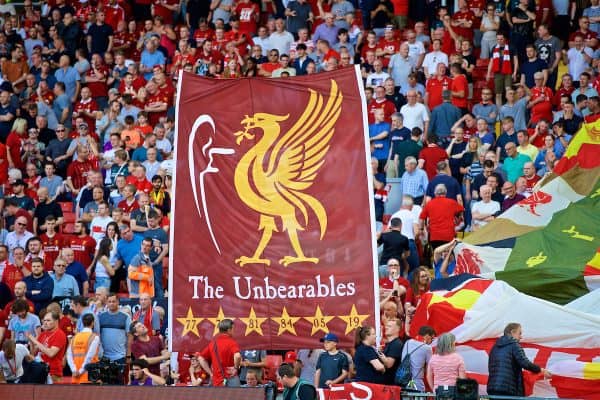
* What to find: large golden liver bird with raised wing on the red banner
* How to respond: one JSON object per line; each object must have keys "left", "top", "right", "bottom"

{"left": 234, "top": 80, "right": 343, "bottom": 266}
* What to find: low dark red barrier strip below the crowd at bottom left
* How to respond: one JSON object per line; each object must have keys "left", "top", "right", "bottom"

{"left": 0, "top": 385, "right": 265, "bottom": 400}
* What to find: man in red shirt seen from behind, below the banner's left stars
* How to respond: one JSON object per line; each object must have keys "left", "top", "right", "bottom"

{"left": 199, "top": 318, "right": 242, "bottom": 386}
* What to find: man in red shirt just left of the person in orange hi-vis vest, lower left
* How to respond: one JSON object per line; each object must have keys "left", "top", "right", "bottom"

{"left": 27, "top": 312, "right": 68, "bottom": 383}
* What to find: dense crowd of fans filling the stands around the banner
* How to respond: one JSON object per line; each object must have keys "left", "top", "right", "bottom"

{"left": 0, "top": 0, "right": 600, "bottom": 398}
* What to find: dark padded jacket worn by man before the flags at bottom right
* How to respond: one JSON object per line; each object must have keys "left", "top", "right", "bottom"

{"left": 487, "top": 335, "right": 541, "bottom": 396}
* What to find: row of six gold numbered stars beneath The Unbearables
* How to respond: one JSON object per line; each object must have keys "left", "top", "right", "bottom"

{"left": 176, "top": 304, "right": 369, "bottom": 337}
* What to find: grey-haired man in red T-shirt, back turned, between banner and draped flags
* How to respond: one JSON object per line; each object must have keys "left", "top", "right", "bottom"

{"left": 420, "top": 183, "right": 465, "bottom": 250}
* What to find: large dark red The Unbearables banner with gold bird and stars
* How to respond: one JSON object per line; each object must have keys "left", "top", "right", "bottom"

{"left": 169, "top": 68, "right": 376, "bottom": 351}
